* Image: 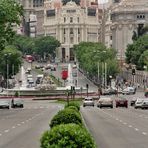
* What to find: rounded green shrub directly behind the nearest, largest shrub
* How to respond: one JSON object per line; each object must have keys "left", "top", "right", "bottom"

{"left": 50, "top": 108, "right": 82, "bottom": 128}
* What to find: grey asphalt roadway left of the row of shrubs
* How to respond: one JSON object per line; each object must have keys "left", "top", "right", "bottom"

{"left": 0, "top": 100, "right": 62, "bottom": 148}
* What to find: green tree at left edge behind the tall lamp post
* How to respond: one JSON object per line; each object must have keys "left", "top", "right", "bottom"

{"left": 0, "top": 46, "right": 22, "bottom": 78}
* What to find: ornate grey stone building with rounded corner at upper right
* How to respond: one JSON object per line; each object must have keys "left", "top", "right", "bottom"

{"left": 108, "top": 0, "right": 148, "bottom": 61}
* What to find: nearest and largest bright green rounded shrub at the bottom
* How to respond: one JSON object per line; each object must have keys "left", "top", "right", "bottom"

{"left": 40, "top": 124, "right": 96, "bottom": 148}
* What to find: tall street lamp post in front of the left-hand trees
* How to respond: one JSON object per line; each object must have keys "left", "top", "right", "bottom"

{"left": 4, "top": 53, "right": 11, "bottom": 96}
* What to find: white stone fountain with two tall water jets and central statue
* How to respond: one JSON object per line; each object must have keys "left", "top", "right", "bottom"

{"left": 2, "top": 64, "right": 85, "bottom": 96}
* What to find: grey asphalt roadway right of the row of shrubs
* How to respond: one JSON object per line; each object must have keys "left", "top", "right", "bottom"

{"left": 81, "top": 93, "right": 148, "bottom": 148}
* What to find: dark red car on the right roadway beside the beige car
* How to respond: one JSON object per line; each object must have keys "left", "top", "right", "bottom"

{"left": 115, "top": 96, "right": 128, "bottom": 108}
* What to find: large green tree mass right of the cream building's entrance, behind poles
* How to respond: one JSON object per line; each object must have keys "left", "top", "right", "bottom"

{"left": 74, "top": 42, "right": 119, "bottom": 77}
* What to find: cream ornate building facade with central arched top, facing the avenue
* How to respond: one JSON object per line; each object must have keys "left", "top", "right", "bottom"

{"left": 44, "top": 1, "right": 101, "bottom": 61}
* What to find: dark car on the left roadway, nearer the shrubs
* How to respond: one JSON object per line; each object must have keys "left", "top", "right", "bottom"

{"left": 11, "top": 98, "right": 24, "bottom": 108}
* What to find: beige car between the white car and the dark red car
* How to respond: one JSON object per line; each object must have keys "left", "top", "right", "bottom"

{"left": 97, "top": 97, "right": 113, "bottom": 108}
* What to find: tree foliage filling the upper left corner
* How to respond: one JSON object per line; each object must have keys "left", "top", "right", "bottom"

{"left": 0, "top": 0, "right": 23, "bottom": 50}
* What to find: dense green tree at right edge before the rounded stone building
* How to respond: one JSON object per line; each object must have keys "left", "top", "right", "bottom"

{"left": 125, "top": 35, "right": 148, "bottom": 70}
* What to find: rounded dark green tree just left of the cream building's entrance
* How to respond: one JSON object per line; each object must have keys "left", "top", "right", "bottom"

{"left": 34, "top": 36, "right": 60, "bottom": 58}
